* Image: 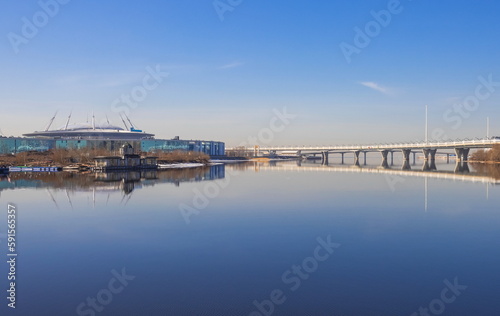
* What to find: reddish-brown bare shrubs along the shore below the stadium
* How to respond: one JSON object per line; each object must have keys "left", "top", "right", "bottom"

{"left": 0, "top": 149, "right": 210, "bottom": 167}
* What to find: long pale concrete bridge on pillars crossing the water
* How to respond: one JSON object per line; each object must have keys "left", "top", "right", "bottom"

{"left": 234, "top": 138, "right": 500, "bottom": 164}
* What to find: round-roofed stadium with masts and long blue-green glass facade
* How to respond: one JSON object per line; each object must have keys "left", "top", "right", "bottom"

{"left": 0, "top": 116, "right": 225, "bottom": 156}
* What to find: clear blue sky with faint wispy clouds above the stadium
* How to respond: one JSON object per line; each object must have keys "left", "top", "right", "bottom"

{"left": 0, "top": 0, "right": 500, "bottom": 146}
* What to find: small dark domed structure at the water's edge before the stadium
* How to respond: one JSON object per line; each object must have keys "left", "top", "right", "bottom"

{"left": 94, "top": 143, "right": 158, "bottom": 171}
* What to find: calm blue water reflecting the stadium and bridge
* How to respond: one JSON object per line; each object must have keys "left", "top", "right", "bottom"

{"left": 0, "top": 162, "right": 500, "bottom": 316}
